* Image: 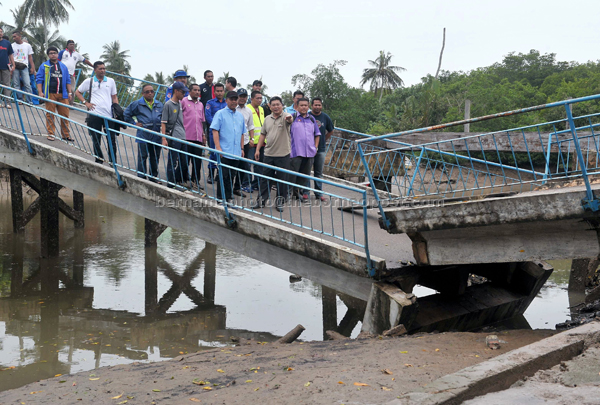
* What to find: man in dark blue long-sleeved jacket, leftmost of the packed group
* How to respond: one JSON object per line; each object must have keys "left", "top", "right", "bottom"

{"left": 124, "top": 84, "right": 163, "bottom": 183}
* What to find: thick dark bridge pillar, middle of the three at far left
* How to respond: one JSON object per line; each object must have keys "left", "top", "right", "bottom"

{"left": 40, "top": 179, "right": 60, "bottom": 257}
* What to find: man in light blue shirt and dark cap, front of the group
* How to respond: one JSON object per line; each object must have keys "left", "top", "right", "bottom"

{"left": 209, "top": 91, "right": 246, "bottom": 201}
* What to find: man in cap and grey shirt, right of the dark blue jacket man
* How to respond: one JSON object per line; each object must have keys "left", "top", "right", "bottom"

{"left": 160, "top": 81, "right": 189, "bottom": 188}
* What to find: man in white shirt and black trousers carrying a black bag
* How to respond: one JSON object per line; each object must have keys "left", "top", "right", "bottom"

{"left": 75, "top": 61, "right": 119, "bottom": 164}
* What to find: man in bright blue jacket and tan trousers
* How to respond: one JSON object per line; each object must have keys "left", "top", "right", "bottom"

{"left": 35, "top": 46, "right": 73, "bottom": 141}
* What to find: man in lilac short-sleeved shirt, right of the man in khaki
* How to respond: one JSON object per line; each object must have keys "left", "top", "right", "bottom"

{"left": 290, "top": 97, "right": 321, "bottom": 202}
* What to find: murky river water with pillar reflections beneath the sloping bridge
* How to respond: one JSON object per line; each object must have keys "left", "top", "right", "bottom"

{"left": 0, "top": 194, "right": 365, "bottom": 391}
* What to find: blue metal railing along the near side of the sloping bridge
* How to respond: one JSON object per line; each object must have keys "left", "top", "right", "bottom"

{"left": 0, "top": 86, "right": 375, "bottom": 276}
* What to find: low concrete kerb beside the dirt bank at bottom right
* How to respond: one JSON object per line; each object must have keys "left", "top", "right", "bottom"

{"left": 389, "top": 322, "right": 600, "bottom": 405}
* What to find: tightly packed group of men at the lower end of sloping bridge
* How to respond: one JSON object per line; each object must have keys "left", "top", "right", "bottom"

{"left": 125, "top": 70, "right": 333, "bottom": 211}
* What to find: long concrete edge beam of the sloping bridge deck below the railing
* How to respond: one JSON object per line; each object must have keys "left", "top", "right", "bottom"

{"left": 0, "top": 130, "right": 385, "bottom": 277}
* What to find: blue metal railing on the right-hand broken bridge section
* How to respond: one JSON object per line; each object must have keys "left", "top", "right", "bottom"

{"left": 356, "top": 95, "right": 600, "bottom": 226}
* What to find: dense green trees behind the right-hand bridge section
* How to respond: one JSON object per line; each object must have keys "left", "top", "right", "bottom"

{"left": 292, "top": 50, "right": 600, "bottom": 135}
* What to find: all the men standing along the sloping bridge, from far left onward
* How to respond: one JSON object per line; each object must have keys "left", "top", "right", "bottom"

{"left": 0, "top": 32, "right": 333, "bottom": 211}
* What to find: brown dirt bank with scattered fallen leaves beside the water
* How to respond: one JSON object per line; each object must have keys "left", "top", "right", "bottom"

{"left": 0, "top": 330, "right": 556, "bottom": 404}
